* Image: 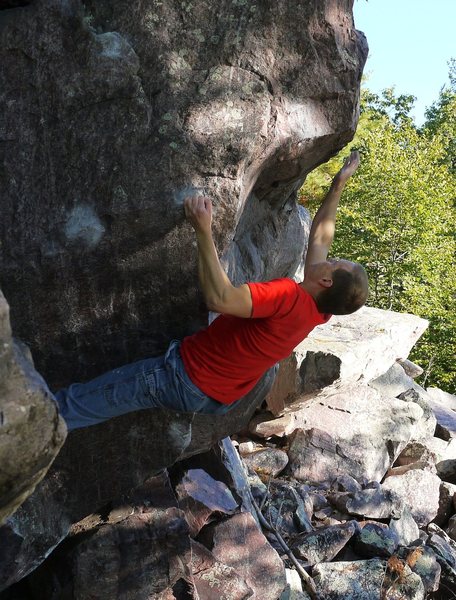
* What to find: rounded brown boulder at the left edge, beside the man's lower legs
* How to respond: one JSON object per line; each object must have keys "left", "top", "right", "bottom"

{"left": 0, "top": 291, "right": 66, "bottom": 524}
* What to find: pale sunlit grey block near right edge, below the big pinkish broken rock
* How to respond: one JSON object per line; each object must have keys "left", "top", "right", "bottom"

{"left": 382, "top": 469, "right": 441, "bottom": 525}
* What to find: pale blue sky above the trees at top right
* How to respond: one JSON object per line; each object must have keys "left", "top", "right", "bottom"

{"left": 353, "top": 0, "right": 456, "bottom": 125}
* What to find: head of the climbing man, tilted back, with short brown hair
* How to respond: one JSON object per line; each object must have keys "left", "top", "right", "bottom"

{"left": 304, "top": 259, "right": 369, "bottom": 315}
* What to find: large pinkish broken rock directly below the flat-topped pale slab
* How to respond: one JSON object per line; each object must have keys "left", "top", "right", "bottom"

{"left": 287, "top": 384, "right": 423, "bottom": 482}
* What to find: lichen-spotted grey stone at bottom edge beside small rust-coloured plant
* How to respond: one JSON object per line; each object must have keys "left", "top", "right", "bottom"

{"left": 312, "top": 558, "right": 424, "bottom": 600}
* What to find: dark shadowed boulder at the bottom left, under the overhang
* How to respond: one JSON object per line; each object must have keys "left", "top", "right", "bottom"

{"left": 24, "top": 508, "right": 192, "bottom": 600}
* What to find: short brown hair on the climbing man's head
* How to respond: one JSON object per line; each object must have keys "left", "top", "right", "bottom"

{"left": 316, "top": 263, "right": 369, "bottom": 315}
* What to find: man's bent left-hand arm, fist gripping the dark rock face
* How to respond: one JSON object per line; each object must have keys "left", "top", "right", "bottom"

{"left": 184, "top": 196, "right": 252, "bottom": 318}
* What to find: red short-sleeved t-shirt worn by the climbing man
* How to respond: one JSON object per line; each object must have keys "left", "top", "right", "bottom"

{"left": 181, "top": 278, "right": 331, "bottom": 404}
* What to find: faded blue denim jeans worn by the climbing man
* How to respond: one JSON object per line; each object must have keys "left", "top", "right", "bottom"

{"left": 55, "top": 340, "right": 233, "bottom": 431}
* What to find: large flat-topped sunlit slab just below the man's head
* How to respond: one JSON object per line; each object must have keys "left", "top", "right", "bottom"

{"left": 267, "top": 307, "right": 428, "bottom": 415}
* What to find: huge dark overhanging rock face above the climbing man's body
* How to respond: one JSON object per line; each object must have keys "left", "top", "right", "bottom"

{"left": 0, "top": 0, "right": 367, "bottom": 387}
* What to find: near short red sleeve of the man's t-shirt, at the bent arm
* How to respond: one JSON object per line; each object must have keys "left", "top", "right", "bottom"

{"left": 248, "top": 278, "right": 298, "bottom": 319}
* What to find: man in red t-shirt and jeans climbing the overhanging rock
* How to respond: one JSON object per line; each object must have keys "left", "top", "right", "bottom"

{"left": 56, "top": 152, "right": 368, "bottom": 430}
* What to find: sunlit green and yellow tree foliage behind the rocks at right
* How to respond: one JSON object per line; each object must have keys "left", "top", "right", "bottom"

{"left": 301, "top": 72, "right": 456, "bottom": 392}
